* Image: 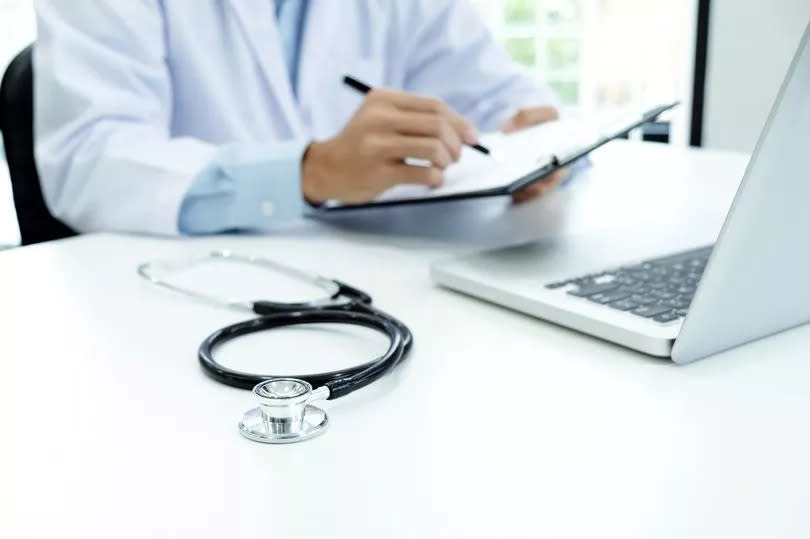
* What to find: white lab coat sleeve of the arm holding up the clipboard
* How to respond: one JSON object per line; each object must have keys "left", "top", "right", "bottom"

{"left": 396, "top": 0, "right": 559, "bottom": 131}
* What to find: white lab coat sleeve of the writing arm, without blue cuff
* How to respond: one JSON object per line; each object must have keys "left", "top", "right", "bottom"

{"left": 34, "top": 0, "right": 200, "bottom": 234}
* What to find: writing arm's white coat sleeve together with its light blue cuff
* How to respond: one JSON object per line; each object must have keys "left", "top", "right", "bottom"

{"left": 34, "top": 0, "right": 303, "bottom": 234}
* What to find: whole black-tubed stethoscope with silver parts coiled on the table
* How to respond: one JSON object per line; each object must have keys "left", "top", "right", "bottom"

{"left": 138, "top": 251, "right": 413, "bottom": 444}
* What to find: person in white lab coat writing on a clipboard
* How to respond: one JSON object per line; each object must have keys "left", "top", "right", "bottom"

{"left": 34, "top": 0, "right": 560, "bottom": 234}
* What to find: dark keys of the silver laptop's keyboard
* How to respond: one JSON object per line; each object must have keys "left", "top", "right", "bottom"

{"left": 546, "top": 246, "right": 712, "bottom": 324}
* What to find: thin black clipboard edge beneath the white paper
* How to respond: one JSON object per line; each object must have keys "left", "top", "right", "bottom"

{"left": 314, "top": 102, "right": 680, "bottom": 215}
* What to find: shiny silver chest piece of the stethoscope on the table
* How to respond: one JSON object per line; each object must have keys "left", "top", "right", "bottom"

{"left": 239, "top": 378, "right": 329, "bottom": 444}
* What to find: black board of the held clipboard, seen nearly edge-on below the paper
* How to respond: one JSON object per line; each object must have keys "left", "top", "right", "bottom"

{"left": 314, "top": 101, "right": 680, "bottom": 214}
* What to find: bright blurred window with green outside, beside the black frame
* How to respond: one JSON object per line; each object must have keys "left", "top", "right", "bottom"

{"left": 471, "top": 0, "right": 697, "bottom": 144}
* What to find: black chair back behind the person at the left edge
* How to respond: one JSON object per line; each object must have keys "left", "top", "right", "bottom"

{"left": 0, "top": 46, "right": 76, "bottom": 245}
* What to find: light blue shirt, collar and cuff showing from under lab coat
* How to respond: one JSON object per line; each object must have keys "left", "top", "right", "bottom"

{"left": 178, "top": 0, "right": 309, "bottom": 234}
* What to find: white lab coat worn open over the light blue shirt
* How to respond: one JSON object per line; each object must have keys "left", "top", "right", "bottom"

{"left": 34, "top": 0, "right": 554, "bottom": 234}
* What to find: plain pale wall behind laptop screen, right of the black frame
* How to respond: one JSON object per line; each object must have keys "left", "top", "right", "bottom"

{"left": 703, "top": 0, "right": 810, "bottom": 152}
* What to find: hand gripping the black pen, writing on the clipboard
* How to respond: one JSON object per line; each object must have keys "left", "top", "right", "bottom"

{"left": 301, "top": 89, "right": 478, "bottom": 203}
